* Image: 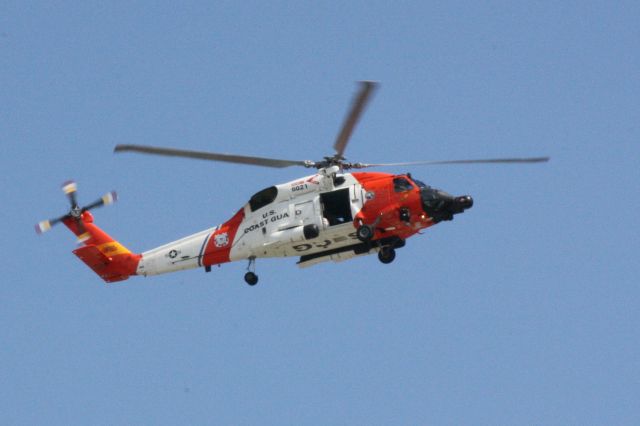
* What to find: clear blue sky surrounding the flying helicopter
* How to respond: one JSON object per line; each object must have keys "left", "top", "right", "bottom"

{"left": 0, "top": 1, "right": 640, "bottom": 425}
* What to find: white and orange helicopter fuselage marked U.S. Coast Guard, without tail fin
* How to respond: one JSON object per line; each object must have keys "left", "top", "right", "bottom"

{"left": 136, "top": 170, "right": 470, "bottom": 275}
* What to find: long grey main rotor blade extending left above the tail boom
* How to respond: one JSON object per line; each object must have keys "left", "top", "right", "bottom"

{"left": 113, "top": 145, "right": 315, "bottom": 168}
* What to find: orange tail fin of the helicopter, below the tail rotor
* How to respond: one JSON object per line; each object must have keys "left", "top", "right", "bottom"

{"left": 62, "top": 211, "right": 142, "bottom": 283}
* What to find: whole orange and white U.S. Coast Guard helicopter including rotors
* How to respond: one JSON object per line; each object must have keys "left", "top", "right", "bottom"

{"left": 36, "top": 81, "right": 549, "bottom": 285}
